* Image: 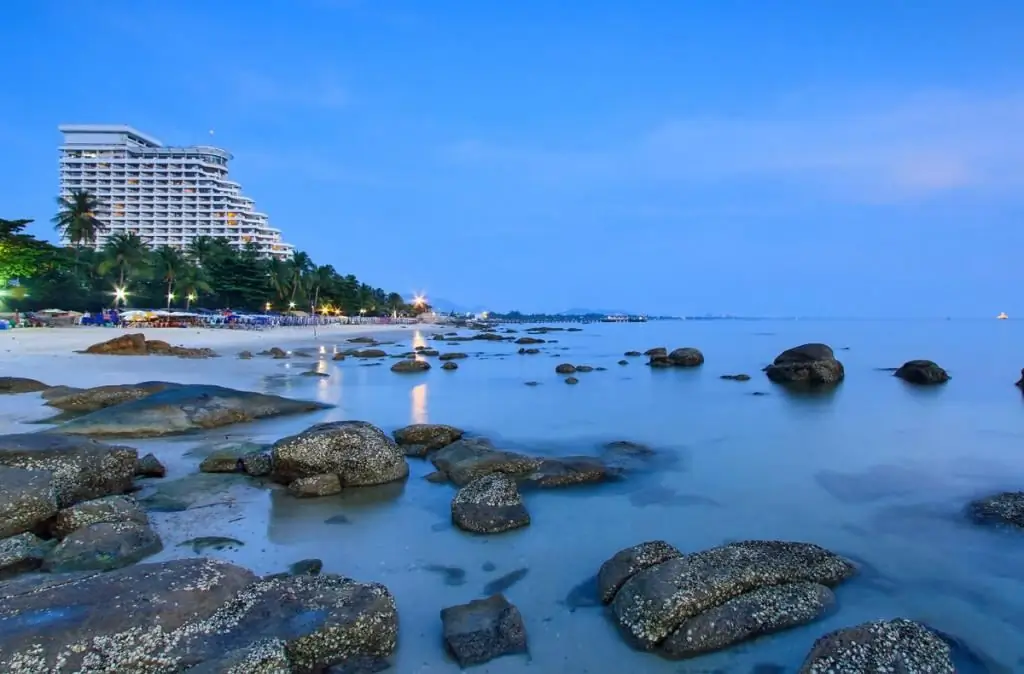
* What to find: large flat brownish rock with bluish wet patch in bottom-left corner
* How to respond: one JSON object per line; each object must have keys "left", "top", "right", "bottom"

{"left": 0, "top": 558, "right": 256, "bottom": 673}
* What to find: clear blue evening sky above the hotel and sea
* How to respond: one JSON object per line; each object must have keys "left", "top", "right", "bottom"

{"left": 0, "top": 0, "right": 1024, "bottom": 317}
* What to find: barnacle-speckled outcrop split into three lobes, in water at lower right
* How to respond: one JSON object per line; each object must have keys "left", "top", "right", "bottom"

{"left": 598, "top": 541, "right": 856, "bottom": 659}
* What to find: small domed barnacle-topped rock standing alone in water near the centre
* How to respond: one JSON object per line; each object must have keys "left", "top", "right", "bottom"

{"left": 452, "top": 473, "right": 529, "bottom": 534}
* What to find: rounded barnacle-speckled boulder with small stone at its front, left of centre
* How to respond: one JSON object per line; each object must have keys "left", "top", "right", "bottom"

{"left": 271, "top": 421, "right": 409, "bottom": 487}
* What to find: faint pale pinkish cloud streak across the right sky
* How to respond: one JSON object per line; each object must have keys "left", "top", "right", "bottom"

{"left": 442, "top": 94, "right": 1024, "bottom": 202}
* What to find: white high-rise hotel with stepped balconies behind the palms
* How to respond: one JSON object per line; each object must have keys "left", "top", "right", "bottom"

{"left": 59, "top": 124, "right": 293, "bottom": 258}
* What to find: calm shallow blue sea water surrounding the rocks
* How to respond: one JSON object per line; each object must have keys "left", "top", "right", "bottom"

{"left": 6, "top": 321, "right": 1024, "bottom": 674}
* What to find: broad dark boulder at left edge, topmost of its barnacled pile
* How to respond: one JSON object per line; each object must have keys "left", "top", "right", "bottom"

{"left": 0, "top": 432, "right": 138, "bottom": 508}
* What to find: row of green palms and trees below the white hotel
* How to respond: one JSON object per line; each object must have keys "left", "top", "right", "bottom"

{"left": 0, "top": 192, "right": 428, "bottom": 315}
